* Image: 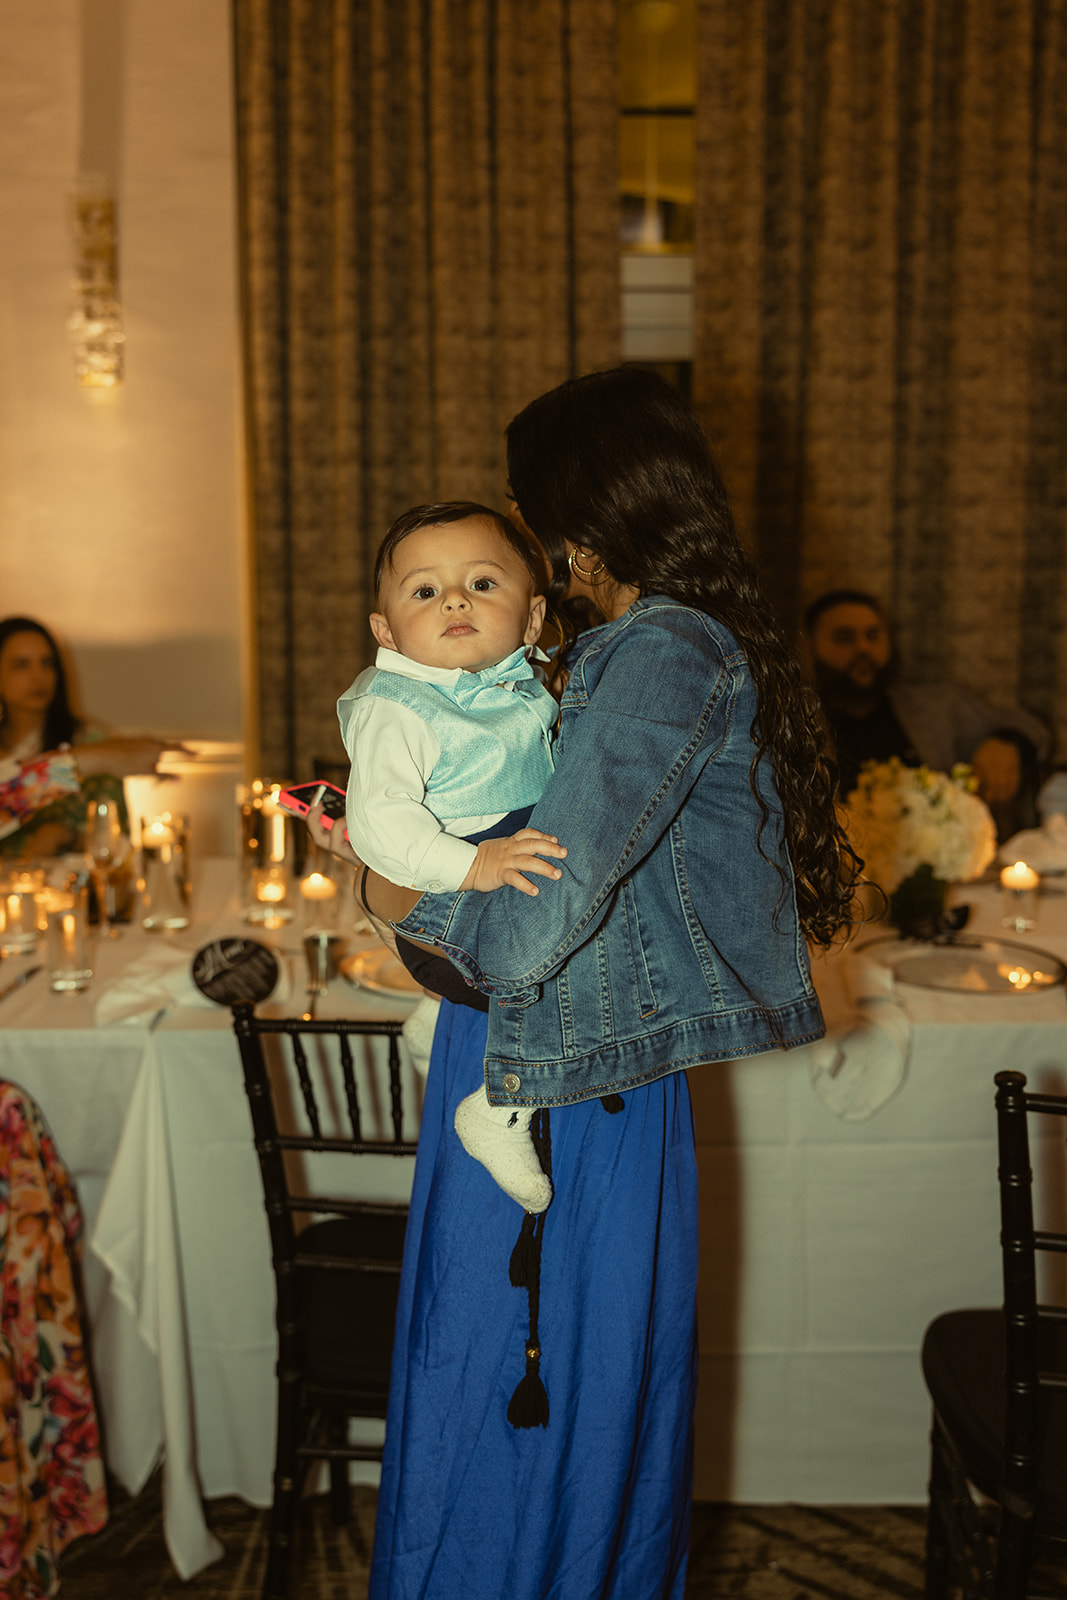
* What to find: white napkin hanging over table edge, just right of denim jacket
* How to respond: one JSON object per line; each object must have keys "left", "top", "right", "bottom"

{"left": 808, "top": 952, "right": 912, "bottom": 1122}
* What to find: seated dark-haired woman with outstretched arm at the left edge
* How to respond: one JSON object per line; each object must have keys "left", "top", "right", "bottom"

{"left": 0, "top": 616, "right": 184, "bottom": 856}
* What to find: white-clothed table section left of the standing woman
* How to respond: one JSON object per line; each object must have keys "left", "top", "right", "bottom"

{"left": 0, "top": 861, "right": 421, "bottom": 1578}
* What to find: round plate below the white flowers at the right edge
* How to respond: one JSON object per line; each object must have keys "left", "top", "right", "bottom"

{"left": 857, "top": 936, "right": 1067, "bottom": 995}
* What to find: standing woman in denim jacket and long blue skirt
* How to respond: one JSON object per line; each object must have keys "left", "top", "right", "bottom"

{"left": 316, "top": 368, "right": 856, "bottom": 1600}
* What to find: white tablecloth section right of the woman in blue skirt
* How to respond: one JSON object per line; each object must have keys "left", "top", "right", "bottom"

{"left": 689, "top": 885, "right": 1067, "bottom": 1504}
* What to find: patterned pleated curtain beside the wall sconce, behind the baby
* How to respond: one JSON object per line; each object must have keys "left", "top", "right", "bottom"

{"left": 234, "top": 0, "right": 619, "bottom": 779}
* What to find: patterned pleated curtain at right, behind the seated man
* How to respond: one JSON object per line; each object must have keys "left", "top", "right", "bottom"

{"left": 694, "top": 0, "right": 1067, "bottom": 748}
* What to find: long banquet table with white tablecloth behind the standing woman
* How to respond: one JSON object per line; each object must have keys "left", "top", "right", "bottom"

{"left": 0, "top": 862, "right": 1067, "bottom": 1576}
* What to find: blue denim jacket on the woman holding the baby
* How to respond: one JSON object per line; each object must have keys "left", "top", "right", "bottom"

{"left": 395, "top": 595, "right": 824, "bottom": 1106}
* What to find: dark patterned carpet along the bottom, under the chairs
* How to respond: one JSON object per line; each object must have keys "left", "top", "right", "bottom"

{"left": 61, "top": 1474, "right": 926, "bottom": 1600}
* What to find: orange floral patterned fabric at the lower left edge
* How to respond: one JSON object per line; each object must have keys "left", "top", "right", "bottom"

{"left": 0, "top": 1083, "right": 107, "bottom": 1600}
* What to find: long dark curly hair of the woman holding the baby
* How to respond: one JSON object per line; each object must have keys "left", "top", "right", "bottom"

{"left": 507, "top": 366, "right": 861, "bottom": 944}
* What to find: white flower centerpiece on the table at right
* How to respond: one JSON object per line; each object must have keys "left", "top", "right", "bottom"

{"left": 843, "top": 757, "right": 997, "bottom": 928}
